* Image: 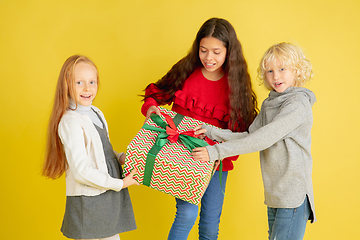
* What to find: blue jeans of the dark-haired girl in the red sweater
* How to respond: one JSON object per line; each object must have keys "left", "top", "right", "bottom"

{"left": 168, "top": 171, "right": 228, "bottom": 240}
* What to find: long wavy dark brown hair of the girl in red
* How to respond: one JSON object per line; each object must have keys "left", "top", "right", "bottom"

{"left": 144, "top": 18, "right": 258, "bottom": 131}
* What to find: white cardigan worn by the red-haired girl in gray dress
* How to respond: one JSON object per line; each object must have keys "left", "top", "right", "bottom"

{"left": 58, "top": 106, "right": 123, "bottom": 196}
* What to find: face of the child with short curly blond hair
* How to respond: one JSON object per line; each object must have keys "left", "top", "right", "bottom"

{"left": 265, "top": 61, "right": 295, "bottom": 93}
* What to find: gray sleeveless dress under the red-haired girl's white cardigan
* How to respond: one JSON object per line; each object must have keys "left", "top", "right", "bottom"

{"left": 61, "top": 118, "right": 136, "bottom": 239}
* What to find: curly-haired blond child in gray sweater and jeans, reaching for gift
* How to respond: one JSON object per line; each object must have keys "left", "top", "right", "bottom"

{"left": 193, "top": 43, "right": 316, "bottom": 240}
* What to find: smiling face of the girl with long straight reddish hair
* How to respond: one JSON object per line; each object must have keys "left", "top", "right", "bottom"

{"left": 74, "top": 62, "right": 98, "bottom": 106}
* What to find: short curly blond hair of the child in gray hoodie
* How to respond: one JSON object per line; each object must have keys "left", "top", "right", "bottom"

{"left": 257, "top": 42, "right": 314, "bottom": 90}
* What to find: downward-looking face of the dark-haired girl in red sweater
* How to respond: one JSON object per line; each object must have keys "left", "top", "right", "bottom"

{"left": 199, "top": 37, "right": 227, "bottom": 81}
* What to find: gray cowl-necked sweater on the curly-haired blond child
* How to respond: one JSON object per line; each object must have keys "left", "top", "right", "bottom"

{"left": 203, "top": 87, "right": 316, "bottom": 222}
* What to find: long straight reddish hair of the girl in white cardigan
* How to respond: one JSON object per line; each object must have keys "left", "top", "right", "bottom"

{"left": 42, "top": 55, "right": 99, "bottom": 179}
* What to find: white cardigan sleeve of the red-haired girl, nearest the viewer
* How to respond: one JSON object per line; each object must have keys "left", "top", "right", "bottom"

{"left": 59, "top": 115, "right": 123, "bottom": 191}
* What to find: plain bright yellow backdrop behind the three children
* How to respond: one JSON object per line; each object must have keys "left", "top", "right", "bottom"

{"left": 0, "top": 0, "right": 360, "bottom": 240}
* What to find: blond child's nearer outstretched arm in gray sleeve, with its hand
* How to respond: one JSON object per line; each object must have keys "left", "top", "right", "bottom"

{"left": 193, "top": 101, "right": 307, "bottom": 161}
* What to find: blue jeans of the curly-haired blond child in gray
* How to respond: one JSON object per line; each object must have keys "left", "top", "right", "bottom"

{"left": 267, "top": 197, "right": 311, "bottom": 240}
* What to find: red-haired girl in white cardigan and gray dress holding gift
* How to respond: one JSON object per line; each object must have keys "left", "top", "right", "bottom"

{"left": 43, "top": 55, "right": 138, "bottom": 240}
